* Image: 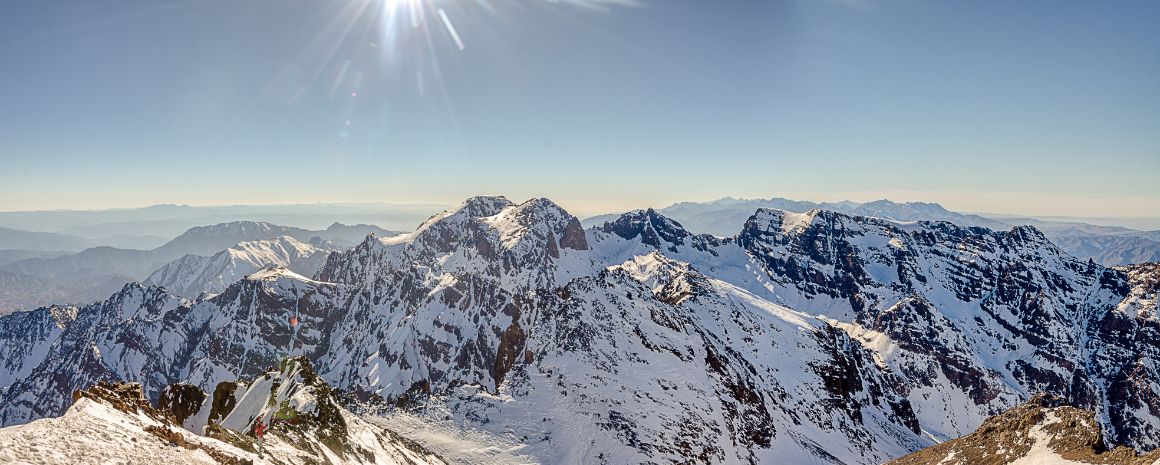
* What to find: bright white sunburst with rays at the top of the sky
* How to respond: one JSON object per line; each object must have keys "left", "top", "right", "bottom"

{"left": 306, "top": 0, "right": 643, "bottom": 138}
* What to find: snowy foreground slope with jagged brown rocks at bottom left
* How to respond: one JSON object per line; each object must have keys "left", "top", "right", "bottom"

{"left": 0, "top": 358, "right": 452, "bottom": 465}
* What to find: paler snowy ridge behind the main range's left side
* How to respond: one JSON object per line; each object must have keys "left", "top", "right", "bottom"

{"left": 144, "top": 235, "right": 340, "bottom": 298}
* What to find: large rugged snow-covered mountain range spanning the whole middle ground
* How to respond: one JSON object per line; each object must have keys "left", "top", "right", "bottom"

{"left": 0, "top": 197, "right": 1160, "bottom": 464}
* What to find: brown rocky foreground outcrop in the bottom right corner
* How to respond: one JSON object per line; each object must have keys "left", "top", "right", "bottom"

{"left": 887, "top": 394, "right": 1160, "bottom": 465}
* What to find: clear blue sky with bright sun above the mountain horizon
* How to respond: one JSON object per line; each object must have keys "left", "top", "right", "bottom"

{"left": 0, "top": 0, "right": 1160, "bottom": 218}
